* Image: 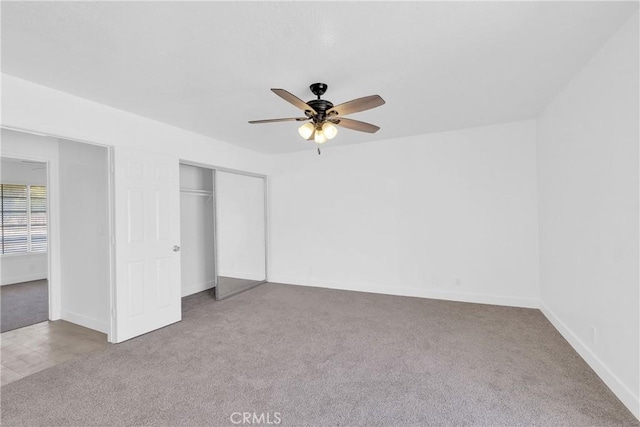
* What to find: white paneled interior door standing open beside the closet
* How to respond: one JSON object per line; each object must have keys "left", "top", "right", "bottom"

{"left": 114, "top": 147, "right": 182, "bottom": 342}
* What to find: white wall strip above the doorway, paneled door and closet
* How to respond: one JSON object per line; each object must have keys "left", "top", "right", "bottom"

{"left": 2, "top": 73, "right": 271, "bottom": 173}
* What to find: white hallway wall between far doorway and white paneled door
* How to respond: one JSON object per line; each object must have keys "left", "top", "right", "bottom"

{"left": 58, "top": 139, "right": 110, "bottom": 333}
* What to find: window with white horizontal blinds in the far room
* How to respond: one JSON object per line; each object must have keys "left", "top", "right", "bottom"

{"left": 0, "top": 184, "right": 47, "bottom": 254}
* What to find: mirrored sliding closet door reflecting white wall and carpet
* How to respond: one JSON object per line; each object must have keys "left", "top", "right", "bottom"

{"left": 214, "top": 171, "right": 266, "bottom": 299}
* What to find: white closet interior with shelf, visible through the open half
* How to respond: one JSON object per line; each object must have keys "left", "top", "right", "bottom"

{"left": 180, "top": 165, "right": 216, "bottom": 297}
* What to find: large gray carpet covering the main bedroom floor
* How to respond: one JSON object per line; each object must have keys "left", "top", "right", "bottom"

{"left": 2, "top": 284, "right": 638, "bottom": 426}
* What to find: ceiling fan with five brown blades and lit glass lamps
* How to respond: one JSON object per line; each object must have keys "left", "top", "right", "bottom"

{"left": 249, "top": 83, "right": 384, "bottom": 154}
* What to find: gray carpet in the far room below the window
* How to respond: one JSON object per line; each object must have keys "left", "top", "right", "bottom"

{"left": 0, "top": 280, "right": 49, "bottom": 332}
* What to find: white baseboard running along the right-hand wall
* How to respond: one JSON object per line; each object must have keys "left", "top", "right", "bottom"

{"left": 540, "top": 301, "right": 640, "bottom": 419}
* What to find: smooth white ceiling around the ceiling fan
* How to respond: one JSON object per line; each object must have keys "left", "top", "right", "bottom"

{"left": 2, "top": 1, "right": 638, "bottom": 153}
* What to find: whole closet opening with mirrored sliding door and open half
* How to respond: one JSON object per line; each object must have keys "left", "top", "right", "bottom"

{"left": 180, "top": 162, "right": 267, "bottom": 300}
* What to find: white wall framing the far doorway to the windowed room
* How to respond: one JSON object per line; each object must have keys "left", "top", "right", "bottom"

{"left": 0, "top": 130, "right": 61, "bottom": 320}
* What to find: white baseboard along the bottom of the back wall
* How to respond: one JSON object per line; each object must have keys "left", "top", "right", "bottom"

{"left": 269, "top": 276, "right": 539, "bottom": 308}
